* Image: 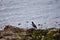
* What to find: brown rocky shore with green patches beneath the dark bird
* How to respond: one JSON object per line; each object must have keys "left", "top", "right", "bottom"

{"left": 0, "top": 25, "right": 60, "bottom": 40}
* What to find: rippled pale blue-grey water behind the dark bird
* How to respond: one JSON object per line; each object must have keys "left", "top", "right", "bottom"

{"left": 0, "top": 0, "right": 60, "bottom": 29}
